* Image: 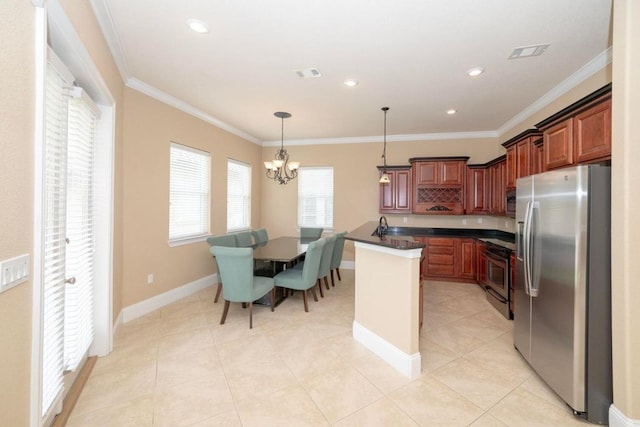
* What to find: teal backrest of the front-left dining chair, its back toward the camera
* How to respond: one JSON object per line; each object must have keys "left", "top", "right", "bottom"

{"left": 210, "top": 246, "right": 253, "bottom": 302}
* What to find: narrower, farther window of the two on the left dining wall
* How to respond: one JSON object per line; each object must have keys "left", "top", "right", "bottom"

{"left": 227, "top": 159, "right": 251, "bottom": 231}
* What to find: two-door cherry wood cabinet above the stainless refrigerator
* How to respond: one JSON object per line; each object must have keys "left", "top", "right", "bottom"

{"left": 536, "top": 84, "right": 611, "bottom": 170}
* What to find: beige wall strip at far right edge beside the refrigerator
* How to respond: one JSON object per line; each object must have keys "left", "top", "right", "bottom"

{"left": 611, "top": 0, "right": 640, "bottom": 425}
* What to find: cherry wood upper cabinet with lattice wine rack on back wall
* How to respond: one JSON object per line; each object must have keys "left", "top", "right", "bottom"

{"left": 409, "top": 157, "right": 469, "bottom": 215}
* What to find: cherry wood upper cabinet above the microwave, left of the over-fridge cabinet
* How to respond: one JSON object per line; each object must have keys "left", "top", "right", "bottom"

{"left": 502, "top": 129, "right": 542, "bottom": 190}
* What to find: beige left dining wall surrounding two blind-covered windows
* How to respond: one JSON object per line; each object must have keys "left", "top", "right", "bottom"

{"left": 122, "top": 89, "right": 262, "bottom": 307}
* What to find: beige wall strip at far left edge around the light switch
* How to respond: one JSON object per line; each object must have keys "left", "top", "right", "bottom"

{"left": 0, "top": 1, "right": 35, "bottom": 426}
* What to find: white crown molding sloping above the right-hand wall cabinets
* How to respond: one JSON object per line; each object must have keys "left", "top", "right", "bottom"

{"left": 496, "top": 46, "right": 613, "bottom": 135}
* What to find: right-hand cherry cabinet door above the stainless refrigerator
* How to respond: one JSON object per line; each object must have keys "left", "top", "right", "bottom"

{"left": 573, "top": 99, "right": 611, "bottom": 163}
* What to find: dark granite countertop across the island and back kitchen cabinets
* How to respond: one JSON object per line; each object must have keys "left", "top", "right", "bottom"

{"left": 345, "top": 221, "right": 515, "bottom": 250}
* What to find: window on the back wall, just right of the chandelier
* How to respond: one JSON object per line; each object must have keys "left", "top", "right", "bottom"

{"left": 298, "top": 167, "right": 333, "bottom": 229}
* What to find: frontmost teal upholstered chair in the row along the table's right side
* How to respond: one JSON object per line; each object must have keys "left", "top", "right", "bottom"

{"left": 273, "top": 239, "right": 325, "bottom": 312}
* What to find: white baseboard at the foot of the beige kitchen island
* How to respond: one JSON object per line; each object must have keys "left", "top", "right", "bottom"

{"left": 353, "top": 320, "right": 422, "bottom": 379}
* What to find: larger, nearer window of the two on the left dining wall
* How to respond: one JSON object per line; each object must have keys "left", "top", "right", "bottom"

{"left": 169, "top": 142, "right": 211, "bottom": 243}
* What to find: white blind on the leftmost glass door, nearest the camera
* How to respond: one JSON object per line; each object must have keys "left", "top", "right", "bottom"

{"left": 41, "top": 50, "right": 73, "bottom": 417}
